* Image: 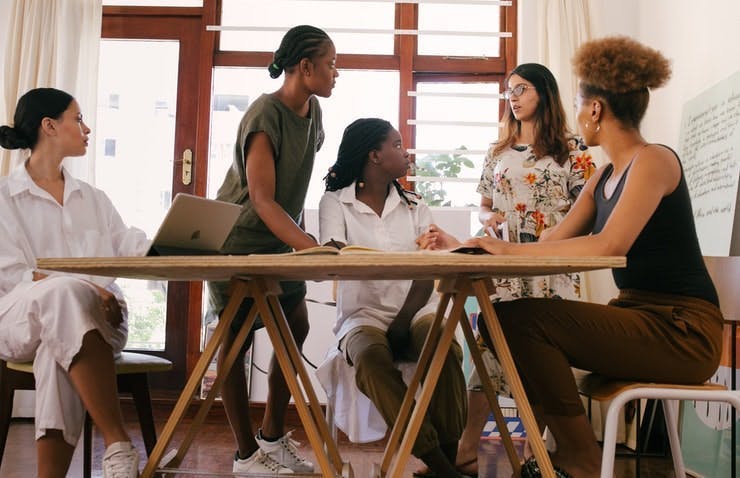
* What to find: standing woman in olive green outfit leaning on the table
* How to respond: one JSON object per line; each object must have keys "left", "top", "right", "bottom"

{"left": 208, "top": 25, "right": 339, "bottom": 474}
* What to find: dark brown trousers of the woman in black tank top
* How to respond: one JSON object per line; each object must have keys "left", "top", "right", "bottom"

{"left": 486, "top": 290, "right": 722, "bottom": 416}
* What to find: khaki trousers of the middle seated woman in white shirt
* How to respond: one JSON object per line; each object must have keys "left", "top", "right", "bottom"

{"left": 340, "top": 315, "right": 467, "bottom": 457}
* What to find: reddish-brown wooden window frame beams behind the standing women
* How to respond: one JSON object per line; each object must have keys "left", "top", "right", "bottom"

{"left": 103, "top": 0, "right": 519, "bottom": 382}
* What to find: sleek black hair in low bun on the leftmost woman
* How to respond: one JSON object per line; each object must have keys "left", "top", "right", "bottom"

{"left": 0, "top": 88, "right": 74, "bottom": 149}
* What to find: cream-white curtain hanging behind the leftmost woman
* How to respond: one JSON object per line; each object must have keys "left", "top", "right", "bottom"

{"left": 0, "top": 0, "right": 103, "bottom": 181}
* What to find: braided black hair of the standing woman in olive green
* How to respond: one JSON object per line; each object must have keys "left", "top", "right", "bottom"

{"left": 267, "top": 25, "right": 331, "bottom": 78}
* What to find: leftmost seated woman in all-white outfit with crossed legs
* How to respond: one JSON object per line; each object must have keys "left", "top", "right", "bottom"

{"left": 0, "top": 88, "right": 149, "bottom": 478}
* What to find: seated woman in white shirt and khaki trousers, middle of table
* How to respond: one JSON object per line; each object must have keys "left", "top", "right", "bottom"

{"left": 319, "top": 118, "right": 466, "bottom": 477}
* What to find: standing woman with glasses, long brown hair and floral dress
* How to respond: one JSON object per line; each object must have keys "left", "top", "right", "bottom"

{"left": 416, "top": 63, "right": 595, "bottom": 474}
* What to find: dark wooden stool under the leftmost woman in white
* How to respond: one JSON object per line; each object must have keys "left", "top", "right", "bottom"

{"left": 0, "top": 352, "right": 172, "bottom": 478}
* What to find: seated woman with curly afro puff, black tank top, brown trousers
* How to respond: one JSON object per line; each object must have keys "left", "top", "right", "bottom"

{"left": 434, "top": 37, "right": 722, "bottom": 478}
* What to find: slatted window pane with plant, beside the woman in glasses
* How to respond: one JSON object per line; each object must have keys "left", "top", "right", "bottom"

{"left": 416, "top": 83, "right": 499, "bottom": 206}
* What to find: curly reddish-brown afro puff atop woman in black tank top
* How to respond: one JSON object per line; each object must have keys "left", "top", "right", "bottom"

{"left": 573, "top": 36, "right": 671, "bottom": 93}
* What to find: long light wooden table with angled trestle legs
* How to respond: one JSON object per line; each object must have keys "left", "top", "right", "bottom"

{"left": 37, "top": 252, "right": 626, "bottom": 478}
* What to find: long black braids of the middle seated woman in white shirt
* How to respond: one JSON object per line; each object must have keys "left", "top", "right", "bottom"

{"left": 324, "top": 118, "right": 421, "bottom": 206}
